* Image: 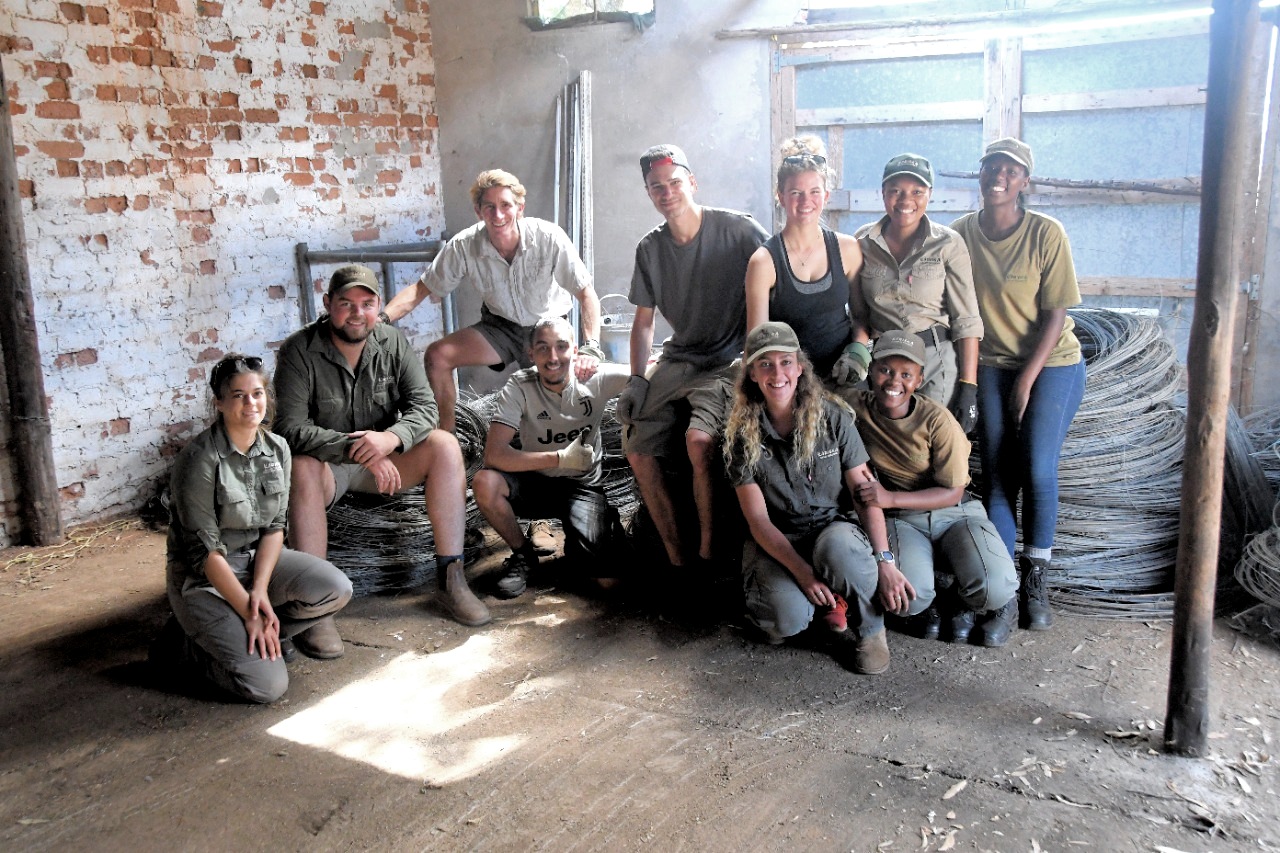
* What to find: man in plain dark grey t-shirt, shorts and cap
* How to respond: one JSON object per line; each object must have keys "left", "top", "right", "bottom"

{"left": 618, "top": 145, "right": 768, "bottom": 566}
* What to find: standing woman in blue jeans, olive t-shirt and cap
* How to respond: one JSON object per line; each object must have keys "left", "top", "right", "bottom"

{"left": 955, "top": 137, "right": 1084, "bottom": 630}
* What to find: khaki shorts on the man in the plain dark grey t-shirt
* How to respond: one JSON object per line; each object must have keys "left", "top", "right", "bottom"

{"left": 622, "top": 359, "right": 741, "bottom": 456}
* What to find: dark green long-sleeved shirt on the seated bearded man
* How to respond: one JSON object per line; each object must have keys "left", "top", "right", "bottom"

{"left": 273, "top": 314, "right": 439, "bottom": 462}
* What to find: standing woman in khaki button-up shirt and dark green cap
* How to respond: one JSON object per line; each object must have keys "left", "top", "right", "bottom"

{"left": 849, "top": 154, "right": 983, "bottom": 433}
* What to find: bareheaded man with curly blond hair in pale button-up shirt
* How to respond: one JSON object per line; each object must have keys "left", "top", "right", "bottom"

{"left": 385, "top": 169, "right": 604, "bottom": 432}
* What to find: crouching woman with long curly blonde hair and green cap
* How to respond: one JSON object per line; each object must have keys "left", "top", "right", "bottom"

{"left": 724, "top": 323, "right": 906, "bottom": 675}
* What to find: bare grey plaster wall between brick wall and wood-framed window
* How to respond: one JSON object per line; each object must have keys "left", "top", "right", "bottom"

{"left": 431, "top": 0, "right": 778, "bottom": 389}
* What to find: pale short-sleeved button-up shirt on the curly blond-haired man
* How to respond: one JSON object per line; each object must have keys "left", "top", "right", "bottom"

{"left": 421, "top": 218, "right": 591, "bottom": 327}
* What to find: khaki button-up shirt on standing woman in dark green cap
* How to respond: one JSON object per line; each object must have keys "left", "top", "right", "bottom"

{"left": 849, "top": 216, "right": 983, "bottom": 341}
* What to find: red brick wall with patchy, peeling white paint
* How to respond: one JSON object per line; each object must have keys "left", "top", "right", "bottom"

{"left": 0, "top": 0, "right": 443, "bottom": 544}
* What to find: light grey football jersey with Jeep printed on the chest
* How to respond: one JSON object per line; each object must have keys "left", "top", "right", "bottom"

{"left": 493, "top": 364, "right": 631, "bottom": 485}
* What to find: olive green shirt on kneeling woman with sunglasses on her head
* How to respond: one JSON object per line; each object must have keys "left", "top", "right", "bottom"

{"left": 168, "top": 420, "right": 292, "bottom": 580}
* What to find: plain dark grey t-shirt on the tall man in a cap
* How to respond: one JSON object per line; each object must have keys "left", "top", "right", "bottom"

{"left": 630, "top": 207, "right": 769, "bottom": 370}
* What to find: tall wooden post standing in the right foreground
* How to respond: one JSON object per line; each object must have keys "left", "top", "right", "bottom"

{"left": 1165, "top": 0, "right": 1258, "bottom": 757}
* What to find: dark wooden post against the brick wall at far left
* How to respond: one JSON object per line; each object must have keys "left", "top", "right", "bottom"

{"left": 0, "top": 65, "right": 63, "bottom": 546}
